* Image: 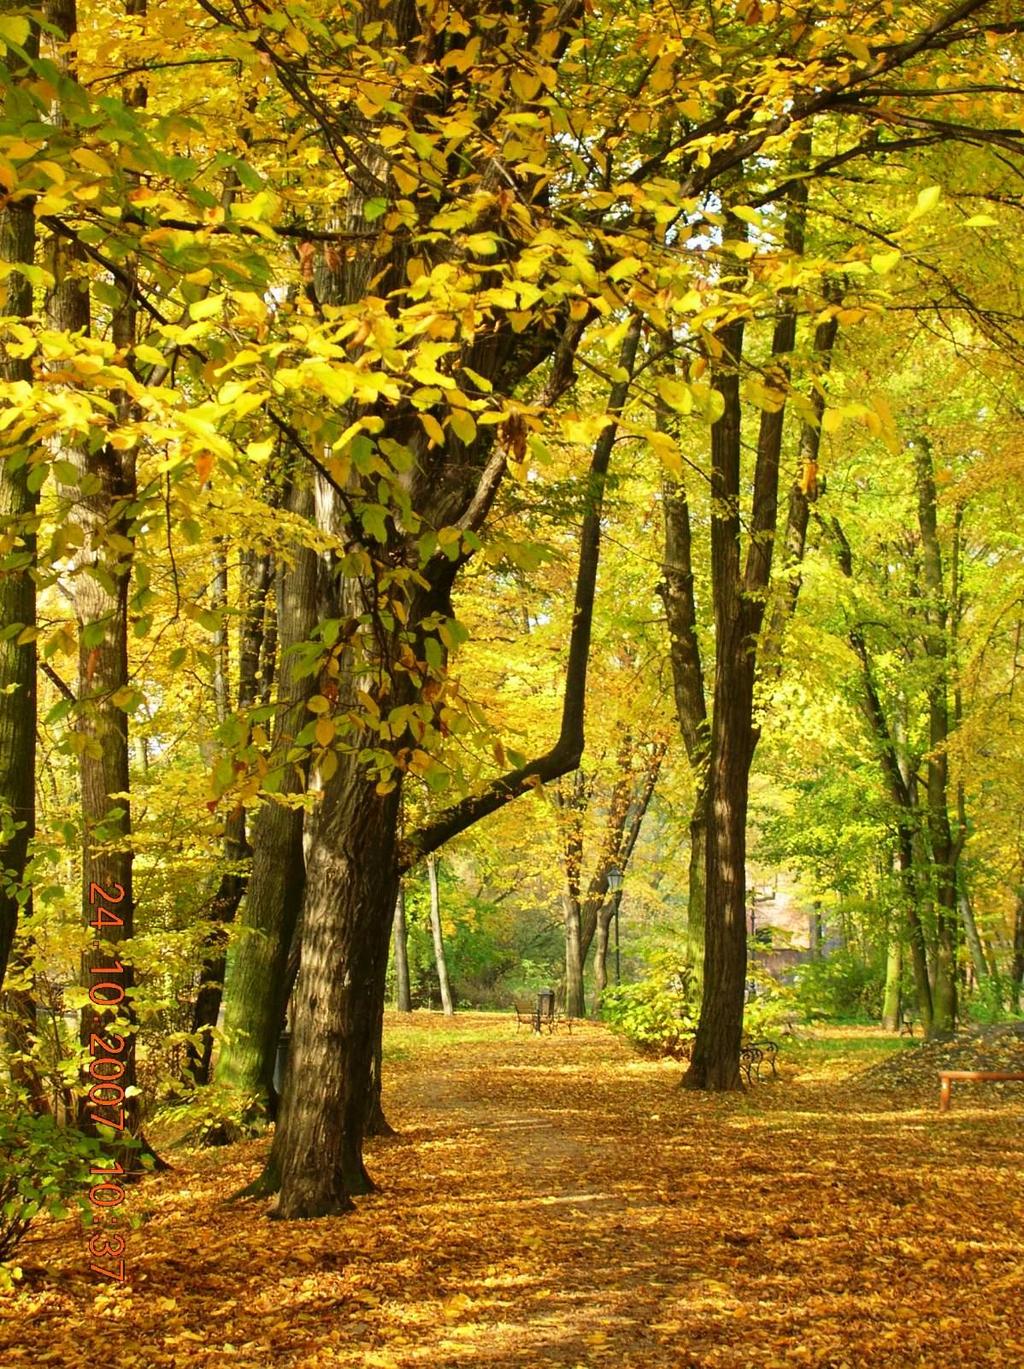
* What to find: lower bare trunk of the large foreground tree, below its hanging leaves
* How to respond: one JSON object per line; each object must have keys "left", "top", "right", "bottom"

{"left": 270, "top": 772, "right": 400, "bottom": 1217}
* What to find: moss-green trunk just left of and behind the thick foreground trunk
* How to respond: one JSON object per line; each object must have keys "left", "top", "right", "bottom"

{"left": 212, "top": 489, "right": 316, "bottom": 1139}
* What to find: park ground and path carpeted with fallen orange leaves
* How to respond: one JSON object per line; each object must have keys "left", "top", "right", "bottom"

{"left": 0, "top": 1013, "right": 1024, "bottom": 1369}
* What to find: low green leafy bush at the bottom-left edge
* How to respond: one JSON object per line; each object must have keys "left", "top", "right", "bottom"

{"left": 0, "top": 1098, "right": 103, "bottom": 1285}
